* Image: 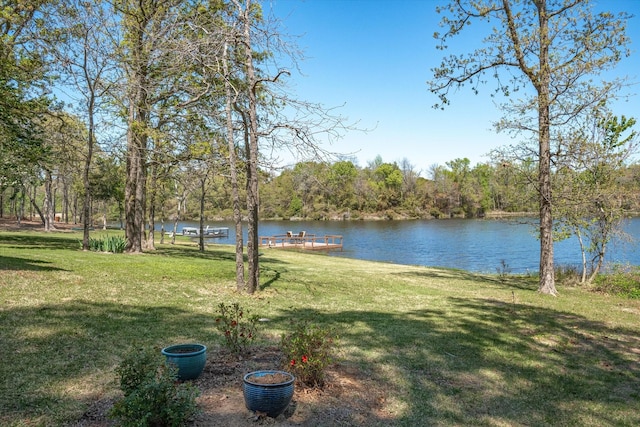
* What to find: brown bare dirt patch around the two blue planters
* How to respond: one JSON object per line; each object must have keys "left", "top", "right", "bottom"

{"left": 74, "top": 347, "right": 385, "bottom": 427}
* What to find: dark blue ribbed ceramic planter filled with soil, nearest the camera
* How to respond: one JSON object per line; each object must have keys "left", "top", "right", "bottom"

{"left": 242, "top": 371, "right": 295, "bottom": 418}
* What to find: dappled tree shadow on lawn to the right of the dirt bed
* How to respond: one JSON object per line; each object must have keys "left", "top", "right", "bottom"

{"left": 272, "top": 298, "right": 640, "bottom": 426}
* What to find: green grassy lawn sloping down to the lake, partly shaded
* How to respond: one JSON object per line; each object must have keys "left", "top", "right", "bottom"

{"left": 0, "top": 231, "right": 640, "bottom": 426}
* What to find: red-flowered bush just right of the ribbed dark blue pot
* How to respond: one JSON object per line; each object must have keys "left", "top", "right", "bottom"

{"left": 281, "top": 322, "right": 337, "bottom": 388}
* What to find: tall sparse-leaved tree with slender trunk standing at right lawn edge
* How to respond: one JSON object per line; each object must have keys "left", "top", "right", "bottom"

{"left": 430, "top": 0, "right": 629, "bottom": 295}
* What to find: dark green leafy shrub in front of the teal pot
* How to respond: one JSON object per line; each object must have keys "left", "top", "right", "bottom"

{"left": 109, "top": 348, "right": 199, "bottom": 427}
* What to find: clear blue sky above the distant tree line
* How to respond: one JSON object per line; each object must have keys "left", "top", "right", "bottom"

{"left": 265, "top": 0, "right": 640, "bottom": 177}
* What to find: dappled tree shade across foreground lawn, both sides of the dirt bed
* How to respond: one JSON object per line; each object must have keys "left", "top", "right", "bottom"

{"left": 0, "top": 297, "right": 640, "bottom": 426}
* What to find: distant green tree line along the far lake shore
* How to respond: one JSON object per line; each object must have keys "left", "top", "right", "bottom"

{"left": 0, "top": 152, "right": 640, "bottom": 226}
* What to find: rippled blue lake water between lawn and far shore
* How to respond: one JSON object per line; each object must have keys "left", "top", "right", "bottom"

{"left": 158, "top": 218, "right": 640, "bottom": 273}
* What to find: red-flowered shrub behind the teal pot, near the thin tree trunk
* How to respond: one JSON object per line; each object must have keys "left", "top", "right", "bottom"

{"left": 216, "top": 302, "right": 258, "bottom": 354}
